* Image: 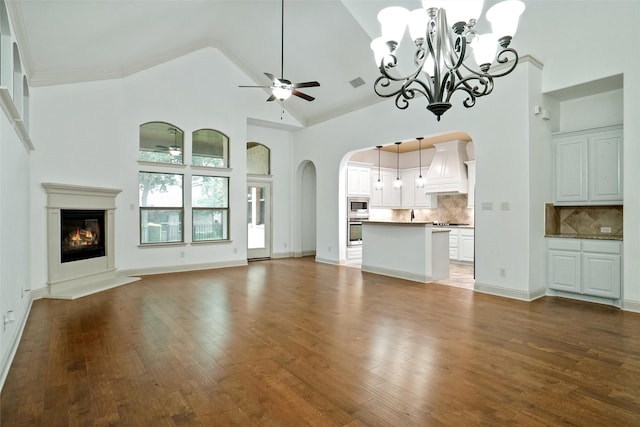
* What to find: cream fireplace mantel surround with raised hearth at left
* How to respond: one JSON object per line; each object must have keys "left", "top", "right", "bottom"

{"left": 42, "top": 182, "right": 139, "bottom": 299}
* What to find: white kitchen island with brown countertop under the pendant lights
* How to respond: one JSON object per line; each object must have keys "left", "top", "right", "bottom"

{"left": 362, "top": 221, "right": 449, "bottom": 282}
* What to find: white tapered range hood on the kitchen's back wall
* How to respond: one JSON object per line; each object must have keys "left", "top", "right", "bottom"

{"left": 424, "top": 141, "right": 469, "bottom": 194}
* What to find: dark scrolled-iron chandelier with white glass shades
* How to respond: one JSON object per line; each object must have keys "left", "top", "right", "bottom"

{"left": 371, "top": 0, "right": 525, "bottom": 120}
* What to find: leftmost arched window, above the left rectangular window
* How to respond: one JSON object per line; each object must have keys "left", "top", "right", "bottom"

{"left": 138, "top": 122, "right": 184, "bottom": 164}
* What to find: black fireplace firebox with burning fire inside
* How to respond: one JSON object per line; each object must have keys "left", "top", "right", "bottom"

{"left": 60, "top": 209, "right": 106, "bottom": 263}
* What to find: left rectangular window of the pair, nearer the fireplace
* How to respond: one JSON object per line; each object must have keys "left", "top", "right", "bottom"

{"left": 140, "top": 172, "right": 184, "bottom": 244}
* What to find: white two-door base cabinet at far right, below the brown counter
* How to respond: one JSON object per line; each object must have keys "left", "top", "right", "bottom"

{"left": 547, "top": 238, "right": 622, "bottom": 299}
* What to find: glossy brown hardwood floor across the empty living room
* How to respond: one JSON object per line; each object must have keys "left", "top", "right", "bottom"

{"left": 0, "top": 258, "right": 640, "bottom": 427}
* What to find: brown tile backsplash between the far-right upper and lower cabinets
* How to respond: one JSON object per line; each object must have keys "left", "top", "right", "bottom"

{"left": 545, "top": 203, "right": 623, "bottom": 237}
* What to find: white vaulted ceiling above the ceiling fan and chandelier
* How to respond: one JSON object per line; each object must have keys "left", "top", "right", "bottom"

{"left": 7, "top": 0, "right": 592, "bottom": 125}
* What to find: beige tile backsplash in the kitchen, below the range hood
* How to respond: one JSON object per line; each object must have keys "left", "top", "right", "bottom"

{"left": 369, "top": 194, "right": 473, "bottom": 225}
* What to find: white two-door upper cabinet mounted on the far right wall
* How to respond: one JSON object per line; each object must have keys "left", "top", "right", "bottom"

{"left": 553, "top": 126, "right": 623, "bottom": 205}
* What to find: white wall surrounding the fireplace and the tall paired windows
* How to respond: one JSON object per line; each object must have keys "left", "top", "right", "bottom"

{"left": 31, "top": 48, "right": 298, "bottom": 288}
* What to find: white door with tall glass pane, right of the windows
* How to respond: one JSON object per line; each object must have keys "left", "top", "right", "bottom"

{"left": 247, "top": 182, "right": 271, "bottom": 259}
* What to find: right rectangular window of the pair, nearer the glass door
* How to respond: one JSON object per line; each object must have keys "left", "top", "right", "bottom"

{"left": 191, "top": 175, "right": 229, "bottom": 242}
